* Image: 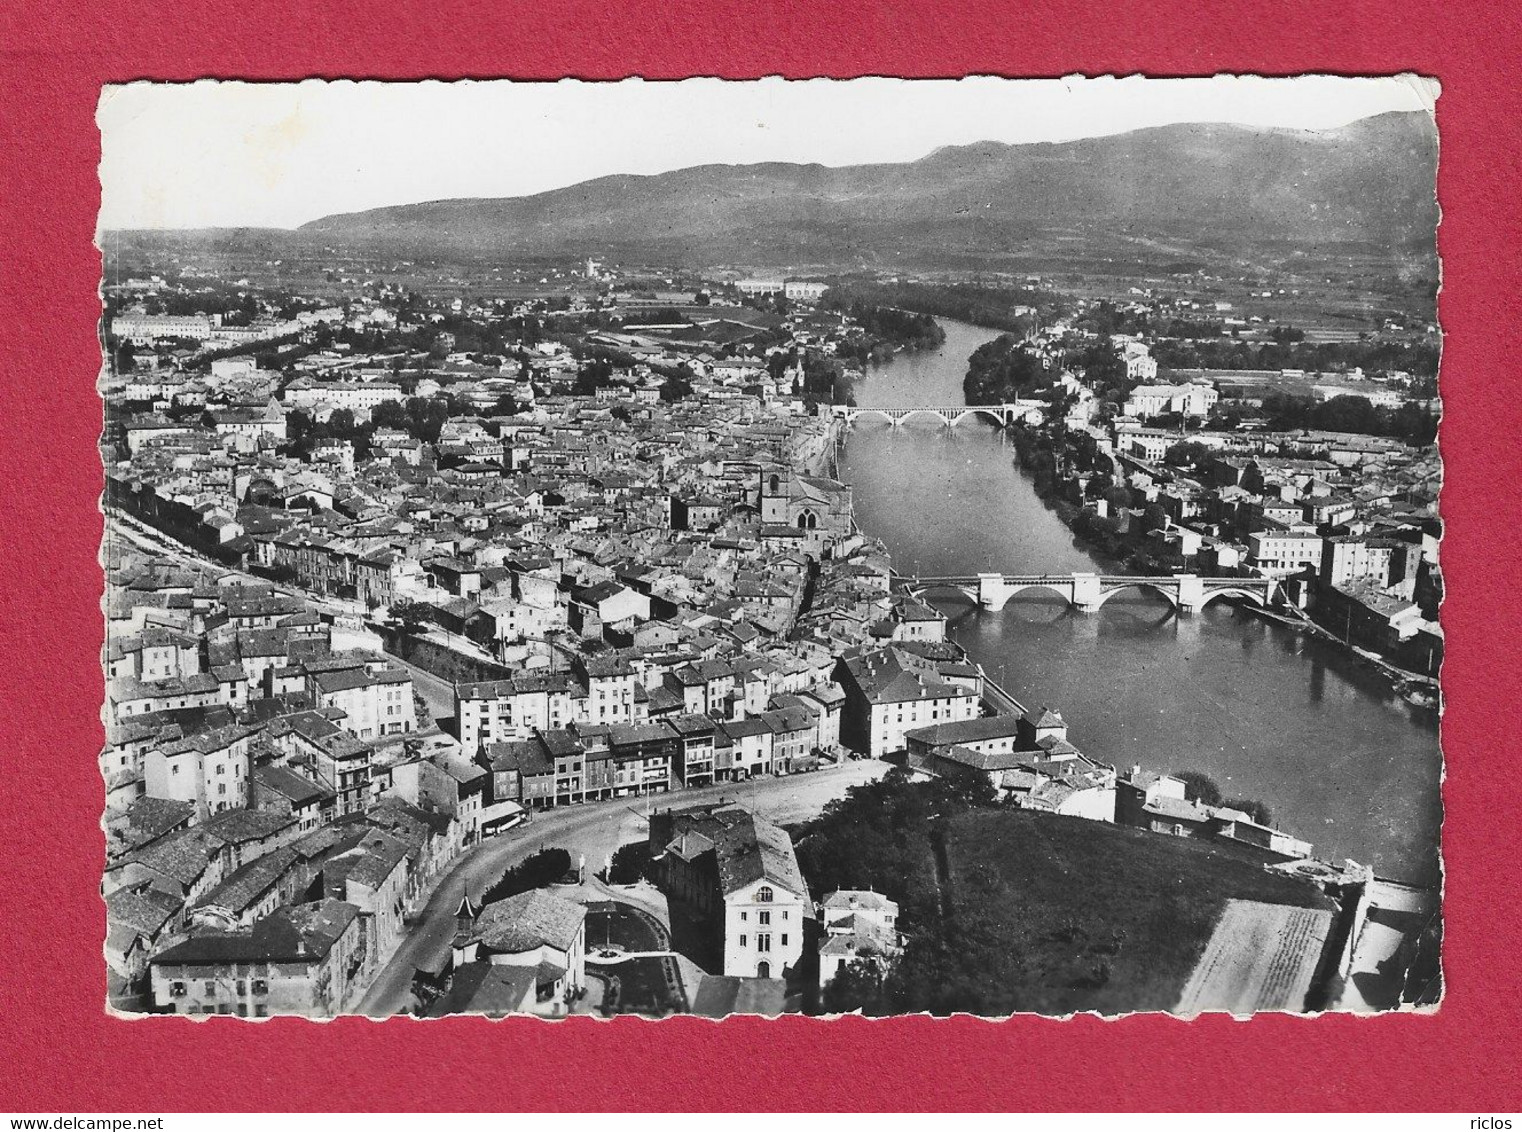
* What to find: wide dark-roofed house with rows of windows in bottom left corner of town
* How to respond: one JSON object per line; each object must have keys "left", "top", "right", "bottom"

{"left": 149, "top": 899, "right": 365, "bottom": 1018}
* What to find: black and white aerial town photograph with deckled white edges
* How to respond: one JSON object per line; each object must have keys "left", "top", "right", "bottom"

{"left": 101, "top": 75, "right": 1458, "bottom": 1025}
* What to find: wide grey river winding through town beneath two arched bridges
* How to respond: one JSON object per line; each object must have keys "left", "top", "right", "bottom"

{"left": 840, "top": 320, "right": 1441, "bottom": 884}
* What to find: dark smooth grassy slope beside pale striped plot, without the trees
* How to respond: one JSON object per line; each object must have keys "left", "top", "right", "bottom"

{"left": 942, "top": 809, "right": 1332, "bottom": 1013}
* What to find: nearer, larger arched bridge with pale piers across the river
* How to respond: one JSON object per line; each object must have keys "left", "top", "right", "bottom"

{"left": 900, "top": 574, "right": 1278, "bottom": 613}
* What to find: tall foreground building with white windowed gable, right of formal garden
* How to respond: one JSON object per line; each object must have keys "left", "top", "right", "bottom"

{"left": 650, "top": 805, "right": 813, "bottom": 978}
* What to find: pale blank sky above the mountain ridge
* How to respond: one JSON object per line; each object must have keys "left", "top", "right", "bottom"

{"left": 96, "top": 75, "right": 1437, "bottom": 231}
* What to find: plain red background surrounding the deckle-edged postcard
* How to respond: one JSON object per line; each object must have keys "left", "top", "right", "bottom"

{"left": 0, "top": 0, "right": 1522, "bottom": 1112}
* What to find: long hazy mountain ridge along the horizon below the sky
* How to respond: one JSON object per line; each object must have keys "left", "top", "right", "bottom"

{"left": 301, "top": 114, "right": 1437, "bottom": 263}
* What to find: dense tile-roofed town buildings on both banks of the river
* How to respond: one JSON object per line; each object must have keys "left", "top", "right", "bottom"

{"left": 100, "top": 254, "right": 1440, "bottom": 1016}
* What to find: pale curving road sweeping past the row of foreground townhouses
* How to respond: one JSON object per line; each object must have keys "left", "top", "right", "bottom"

{"left": 356, "top": 759, "right": 889, "bottom": 1018}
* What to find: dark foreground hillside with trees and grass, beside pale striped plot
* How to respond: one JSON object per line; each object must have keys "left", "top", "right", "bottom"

{"left": 798, "top": 776, "right": 1333, "bottom": 1016}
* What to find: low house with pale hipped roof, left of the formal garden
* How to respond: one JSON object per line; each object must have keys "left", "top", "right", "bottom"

{"left": 452, "top": 889, "right": 586, "bottom": 1016}
